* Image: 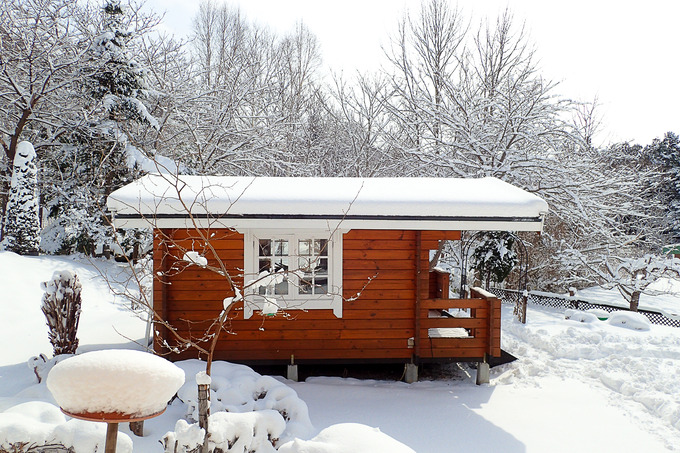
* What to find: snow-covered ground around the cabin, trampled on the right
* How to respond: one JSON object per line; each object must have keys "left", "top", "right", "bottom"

{"left": 0, "top": 252, "right": 680, "bottom": 453}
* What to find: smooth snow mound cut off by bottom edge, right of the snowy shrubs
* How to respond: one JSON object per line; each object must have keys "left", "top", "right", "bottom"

{"left": 279, "top": 423, "right": 415, "bottom": 453}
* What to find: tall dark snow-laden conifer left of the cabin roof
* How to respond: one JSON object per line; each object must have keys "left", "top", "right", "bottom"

{"left": 43, "top": 0, "right": 165, "bottom": 256}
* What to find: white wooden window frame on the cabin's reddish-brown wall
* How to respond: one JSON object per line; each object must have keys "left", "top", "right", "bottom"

{"left": 243, "top": 230, "right": 343, "bottom": 319}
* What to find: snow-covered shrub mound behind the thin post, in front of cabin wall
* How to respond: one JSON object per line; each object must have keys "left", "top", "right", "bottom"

{"left": 176, "top": 360, "right": 314, "bottom": 442}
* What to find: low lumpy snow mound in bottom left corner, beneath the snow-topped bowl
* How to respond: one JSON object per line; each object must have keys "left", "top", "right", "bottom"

{"left": 0, "top": 401, "right": 132, "bottom": 453}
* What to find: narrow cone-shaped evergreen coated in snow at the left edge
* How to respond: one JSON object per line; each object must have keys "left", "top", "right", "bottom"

{"left": 2, "top": 142, "right": 40, "bottom": 255}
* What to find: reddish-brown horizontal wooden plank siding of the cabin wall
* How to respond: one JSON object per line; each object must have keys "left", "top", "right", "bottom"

{"left": 154, "top": 230, "right": 500, "bottom": 362}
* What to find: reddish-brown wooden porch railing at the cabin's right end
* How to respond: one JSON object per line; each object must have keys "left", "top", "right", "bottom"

{"left": 418, "top": 288, "right": 501, "bottom": 360}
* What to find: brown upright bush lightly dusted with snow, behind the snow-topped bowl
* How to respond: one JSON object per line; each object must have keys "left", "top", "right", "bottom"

{"left": 41, "top": 271, "right": 82, "bottom": 356}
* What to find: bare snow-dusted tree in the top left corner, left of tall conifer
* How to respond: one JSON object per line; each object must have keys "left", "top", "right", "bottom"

{"left": 0, "top": 0, "right": 94, "bottom": 237}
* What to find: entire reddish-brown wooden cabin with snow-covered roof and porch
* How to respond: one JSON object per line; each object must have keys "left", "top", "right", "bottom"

{"left": 108, "top": 175, "right": 547, "bottom": 376}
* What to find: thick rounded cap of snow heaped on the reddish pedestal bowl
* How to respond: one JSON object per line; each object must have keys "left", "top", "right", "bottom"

{"left": 47, "top": 349, "right": 184, "bottom": 416}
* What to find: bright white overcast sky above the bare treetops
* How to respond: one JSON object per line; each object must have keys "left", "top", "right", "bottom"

{"left": 147, "top": 0, "right": 680, "bottom": 145}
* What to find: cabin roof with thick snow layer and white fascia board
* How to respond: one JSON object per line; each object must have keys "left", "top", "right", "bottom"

{"left": 107, "top": 175, "right": 548, "bottom": 231}
